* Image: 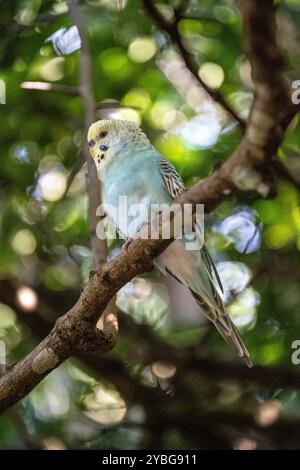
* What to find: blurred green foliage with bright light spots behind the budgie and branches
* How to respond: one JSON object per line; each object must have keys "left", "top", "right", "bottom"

{"left": 0, "top": 0, "right": 300, "bottom": 449}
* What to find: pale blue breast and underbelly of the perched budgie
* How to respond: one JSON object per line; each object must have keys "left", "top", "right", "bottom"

{"left": 103, "top": 143, "right": 221, "bottom": 310}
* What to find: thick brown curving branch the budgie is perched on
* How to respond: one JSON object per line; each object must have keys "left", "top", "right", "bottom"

{"left": 0, "top": 0, "right": 297, "bottom": 412}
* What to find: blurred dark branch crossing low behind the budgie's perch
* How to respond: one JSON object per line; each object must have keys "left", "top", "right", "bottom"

{"left": 0, "top": 281, "right": 300, "bottom": 400}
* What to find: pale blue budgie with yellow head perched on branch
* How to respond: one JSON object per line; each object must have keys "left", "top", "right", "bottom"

{"left": 87, "top": 120, "right": 252, "bottom": 367}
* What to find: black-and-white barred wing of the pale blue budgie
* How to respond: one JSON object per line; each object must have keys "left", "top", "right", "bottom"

{"left": 156, "top": 153, "right": 223, "bottom": 292}
